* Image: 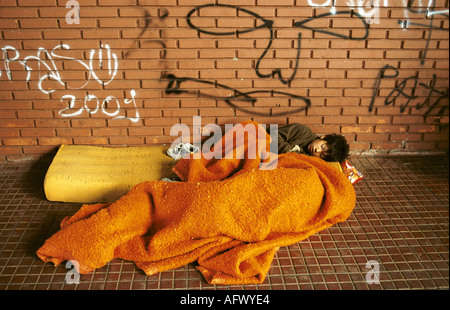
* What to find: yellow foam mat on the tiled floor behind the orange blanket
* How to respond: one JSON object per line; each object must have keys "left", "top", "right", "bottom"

{"left": 44, "top": 145, "right": 176, "bottom": 203}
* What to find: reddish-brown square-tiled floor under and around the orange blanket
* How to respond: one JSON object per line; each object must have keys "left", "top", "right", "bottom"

{"left": 0, "top": 156, "right": 449, "bottom": 290}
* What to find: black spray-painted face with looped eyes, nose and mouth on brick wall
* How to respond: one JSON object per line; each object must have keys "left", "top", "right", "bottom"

{"left": 160, "top": 4, "right": 369, "bottom": 116}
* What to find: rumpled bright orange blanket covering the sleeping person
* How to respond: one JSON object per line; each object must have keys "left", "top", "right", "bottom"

{"left": 37, "top": 122, "right": 355, "bottom": 284}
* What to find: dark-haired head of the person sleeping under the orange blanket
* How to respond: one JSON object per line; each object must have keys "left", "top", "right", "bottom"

{"left": 307, "top": 133, "right": 350, "bottom": 163}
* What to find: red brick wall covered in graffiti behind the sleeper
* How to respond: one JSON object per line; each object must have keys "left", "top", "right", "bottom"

{"left": 0, "top": 0, "right": 449, "bottom": 160}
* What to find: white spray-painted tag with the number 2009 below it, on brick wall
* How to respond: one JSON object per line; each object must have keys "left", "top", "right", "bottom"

{"left": 0, "top": 44, "right": 139, "bottom": 122}
